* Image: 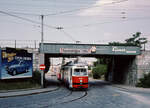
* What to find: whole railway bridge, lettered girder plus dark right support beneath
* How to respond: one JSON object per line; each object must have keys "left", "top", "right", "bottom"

{"left": 39, "top": 43, "right": 141, "bottom": 86}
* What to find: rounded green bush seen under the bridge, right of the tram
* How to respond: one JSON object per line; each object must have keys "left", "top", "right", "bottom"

{"left": 92, "top": 64, "right": 107, "bottom": 79}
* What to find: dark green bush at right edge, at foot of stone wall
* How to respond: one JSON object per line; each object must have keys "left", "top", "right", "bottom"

{"left": 136, "top": 73, "right": 150, "bottom": 88}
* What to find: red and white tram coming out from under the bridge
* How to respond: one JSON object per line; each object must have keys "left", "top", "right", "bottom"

{"left": 57, "top": 62, "right": 88, "bottom": 89}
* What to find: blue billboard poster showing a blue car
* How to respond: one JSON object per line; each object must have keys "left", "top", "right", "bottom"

{"left": 1, "top": 48, "right": 33, "bottom": 79}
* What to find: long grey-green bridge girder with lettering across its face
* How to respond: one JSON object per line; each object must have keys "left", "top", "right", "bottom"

{"left": 40, "top": 43, "right": 141, "bottom": 55}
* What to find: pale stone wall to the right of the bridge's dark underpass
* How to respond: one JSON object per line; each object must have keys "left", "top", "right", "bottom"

{"left": 125, "top": 51, "right": 150, "bottom": 86}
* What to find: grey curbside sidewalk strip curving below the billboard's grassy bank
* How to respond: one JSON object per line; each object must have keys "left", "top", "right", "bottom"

{"left": 0, "top": 86, "right": 59, "bottom": 98}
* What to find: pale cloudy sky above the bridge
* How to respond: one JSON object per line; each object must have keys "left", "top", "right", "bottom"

{"left": 0, "top": 0, "right": 150, "bottom": 47}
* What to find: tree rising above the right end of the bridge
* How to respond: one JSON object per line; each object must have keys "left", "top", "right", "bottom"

{"left": 125, "top": 32, "right": 147, "bottom": 47}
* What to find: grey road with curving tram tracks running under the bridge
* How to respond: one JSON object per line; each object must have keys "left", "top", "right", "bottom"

{"left": 0, "top": 75, "right": 150, "bottom": 108}
